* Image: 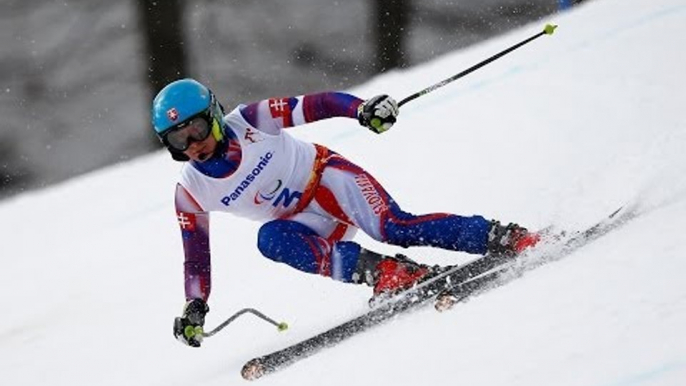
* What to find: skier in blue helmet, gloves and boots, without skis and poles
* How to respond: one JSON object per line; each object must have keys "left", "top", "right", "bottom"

{"left": 152, "top": 79, "right": 540, "bottom": 347}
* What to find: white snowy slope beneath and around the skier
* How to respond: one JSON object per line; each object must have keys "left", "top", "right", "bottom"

{"left": 0, "top": 0, "right": 686, "bottom": 386}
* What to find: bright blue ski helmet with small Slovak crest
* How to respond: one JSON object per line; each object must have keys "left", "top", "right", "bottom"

{"left": 152, "top": 79, "right": 224, "bottom": 161}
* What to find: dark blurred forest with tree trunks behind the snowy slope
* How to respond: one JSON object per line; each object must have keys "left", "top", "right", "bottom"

{"left": 0, "top": 0, "right": 579, "bottom": 198}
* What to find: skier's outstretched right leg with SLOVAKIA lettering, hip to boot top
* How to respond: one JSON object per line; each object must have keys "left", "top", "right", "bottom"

{"left": 315, "top": 155, "right": 492, "bottom": 254}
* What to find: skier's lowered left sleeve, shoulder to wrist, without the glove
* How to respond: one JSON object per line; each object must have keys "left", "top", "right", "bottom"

{"left": 174, "top": 184, "right": 212, "bottom": 301}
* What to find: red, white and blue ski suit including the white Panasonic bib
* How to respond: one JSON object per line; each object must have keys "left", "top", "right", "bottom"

{"left": 175, "top": 92, "right": 490, "bottom": 300}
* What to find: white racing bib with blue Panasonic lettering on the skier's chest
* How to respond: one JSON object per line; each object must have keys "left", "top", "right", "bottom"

{"left": 180, "top": 107, "right": 316, "bottom": 220}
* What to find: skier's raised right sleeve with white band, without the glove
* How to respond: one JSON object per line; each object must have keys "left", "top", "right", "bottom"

{"left": 241, "top": 92, "right": 363, "bottom": 134}
